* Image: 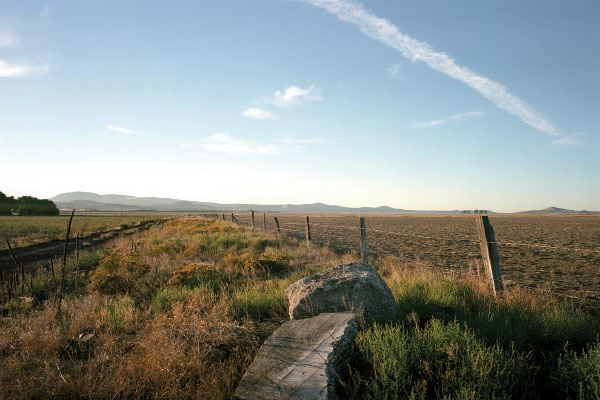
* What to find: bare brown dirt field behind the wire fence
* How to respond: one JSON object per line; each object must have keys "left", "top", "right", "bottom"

{"left": 234, "top": 213, "right": 600, "bottom": 304}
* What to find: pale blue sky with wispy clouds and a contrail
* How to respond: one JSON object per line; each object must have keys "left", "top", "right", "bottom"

{"left": 0, "top": 0, "right": 600, "bottom": 212}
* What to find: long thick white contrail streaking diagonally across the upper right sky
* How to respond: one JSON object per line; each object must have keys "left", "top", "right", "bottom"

{"left": 297, "top": 0, "right": 560, "bottom": 136}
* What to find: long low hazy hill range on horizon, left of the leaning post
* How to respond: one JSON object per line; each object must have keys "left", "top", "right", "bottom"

{"left": 51, "top": 192, "right": 459, "bottom": 214}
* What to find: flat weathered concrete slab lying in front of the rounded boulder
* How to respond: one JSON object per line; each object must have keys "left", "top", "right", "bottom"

{"left": 235, "top": 312, "right": 358, "bottom": 400}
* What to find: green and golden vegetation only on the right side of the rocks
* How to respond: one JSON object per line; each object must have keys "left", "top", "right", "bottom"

{"left": 344, "top": 260, "right": 600, "bottom": 399}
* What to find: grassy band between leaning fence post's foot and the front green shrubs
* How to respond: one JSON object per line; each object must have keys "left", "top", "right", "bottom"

{"left": 390, "top": 278, "right": 600, "bottom": 355}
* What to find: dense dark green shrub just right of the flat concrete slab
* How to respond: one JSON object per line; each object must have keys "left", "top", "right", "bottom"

{"left": 354, "top": 319, "right": 532, "bottom": 399}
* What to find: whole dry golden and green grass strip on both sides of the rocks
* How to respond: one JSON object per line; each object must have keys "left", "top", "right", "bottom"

{"left": 0, "top": 218, "right": 600, "bottom": 399}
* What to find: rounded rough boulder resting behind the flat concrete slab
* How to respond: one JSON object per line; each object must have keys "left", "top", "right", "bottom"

{"left": 285, "top": 262, "right": 398, "bottom": 323}
